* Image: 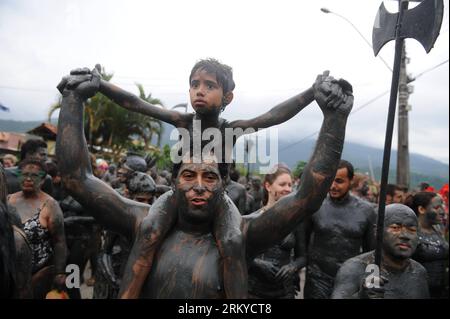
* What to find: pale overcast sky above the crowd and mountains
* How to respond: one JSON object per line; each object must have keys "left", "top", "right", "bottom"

{"left": 0, "top": 0, "right": 449, "bottom": 163}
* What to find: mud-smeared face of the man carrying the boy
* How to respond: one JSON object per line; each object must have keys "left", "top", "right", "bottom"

{"left": 176, "top": 162, "right": 223, "bottom": 222}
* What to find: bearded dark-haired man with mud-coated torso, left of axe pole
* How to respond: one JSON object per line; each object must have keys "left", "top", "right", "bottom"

{"left": 304, "top": 160, "right": 376, "bottom": 299}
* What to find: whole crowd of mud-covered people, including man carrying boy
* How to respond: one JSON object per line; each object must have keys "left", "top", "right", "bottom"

{"left": 0, "top": 60, "right": 449, "bottom": 299}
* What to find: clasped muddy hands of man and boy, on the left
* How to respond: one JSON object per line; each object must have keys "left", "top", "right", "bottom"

{"left": 57, "top": 64, "right": 101, "bottom": 99}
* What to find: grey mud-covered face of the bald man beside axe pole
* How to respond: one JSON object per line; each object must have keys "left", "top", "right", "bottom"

{"left": 383, "top": 211, "right": 418, "bottom": 259}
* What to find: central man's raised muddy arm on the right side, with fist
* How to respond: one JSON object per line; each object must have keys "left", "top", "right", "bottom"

{"left": 243, "top": 78, "right": 353, "bottom": 257}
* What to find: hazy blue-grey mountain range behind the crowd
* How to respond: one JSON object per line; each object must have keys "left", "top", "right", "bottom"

{"left": 0, "top": 119, "right": 449, "bottom": 188}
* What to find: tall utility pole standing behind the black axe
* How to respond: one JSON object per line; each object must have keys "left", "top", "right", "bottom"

{"left": 397, "top": 46, "right": 413, "bottom": 188}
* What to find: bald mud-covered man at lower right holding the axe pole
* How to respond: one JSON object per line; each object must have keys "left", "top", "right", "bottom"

{"left": 331, "top": 204, "right": 429, "bottom": 299}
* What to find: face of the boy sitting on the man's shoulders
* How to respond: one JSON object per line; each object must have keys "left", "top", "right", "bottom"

{"left": 189, "top": 70, "right": 223, "bottom": 115}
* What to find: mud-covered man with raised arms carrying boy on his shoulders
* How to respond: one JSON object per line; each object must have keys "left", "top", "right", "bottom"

{"left": 57, "top": 65, "right": 353, "bottom": 298}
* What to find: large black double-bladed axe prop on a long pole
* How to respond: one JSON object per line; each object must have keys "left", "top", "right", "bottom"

{"left": 372, "top": 0, "right": 444, "bottom": 267}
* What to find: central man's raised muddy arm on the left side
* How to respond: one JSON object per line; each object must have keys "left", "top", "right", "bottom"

{"left": 56, "top": 70, "right": 149, "bottom": 238}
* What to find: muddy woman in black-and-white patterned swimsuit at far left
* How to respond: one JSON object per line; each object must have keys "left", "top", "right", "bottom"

{"left": 8, "top": 157, "right": 67, "bottom": 299}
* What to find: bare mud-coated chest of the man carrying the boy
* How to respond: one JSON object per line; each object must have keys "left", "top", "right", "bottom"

{"left": 141, "top": 229, "right": 224, "bottom": 299}
